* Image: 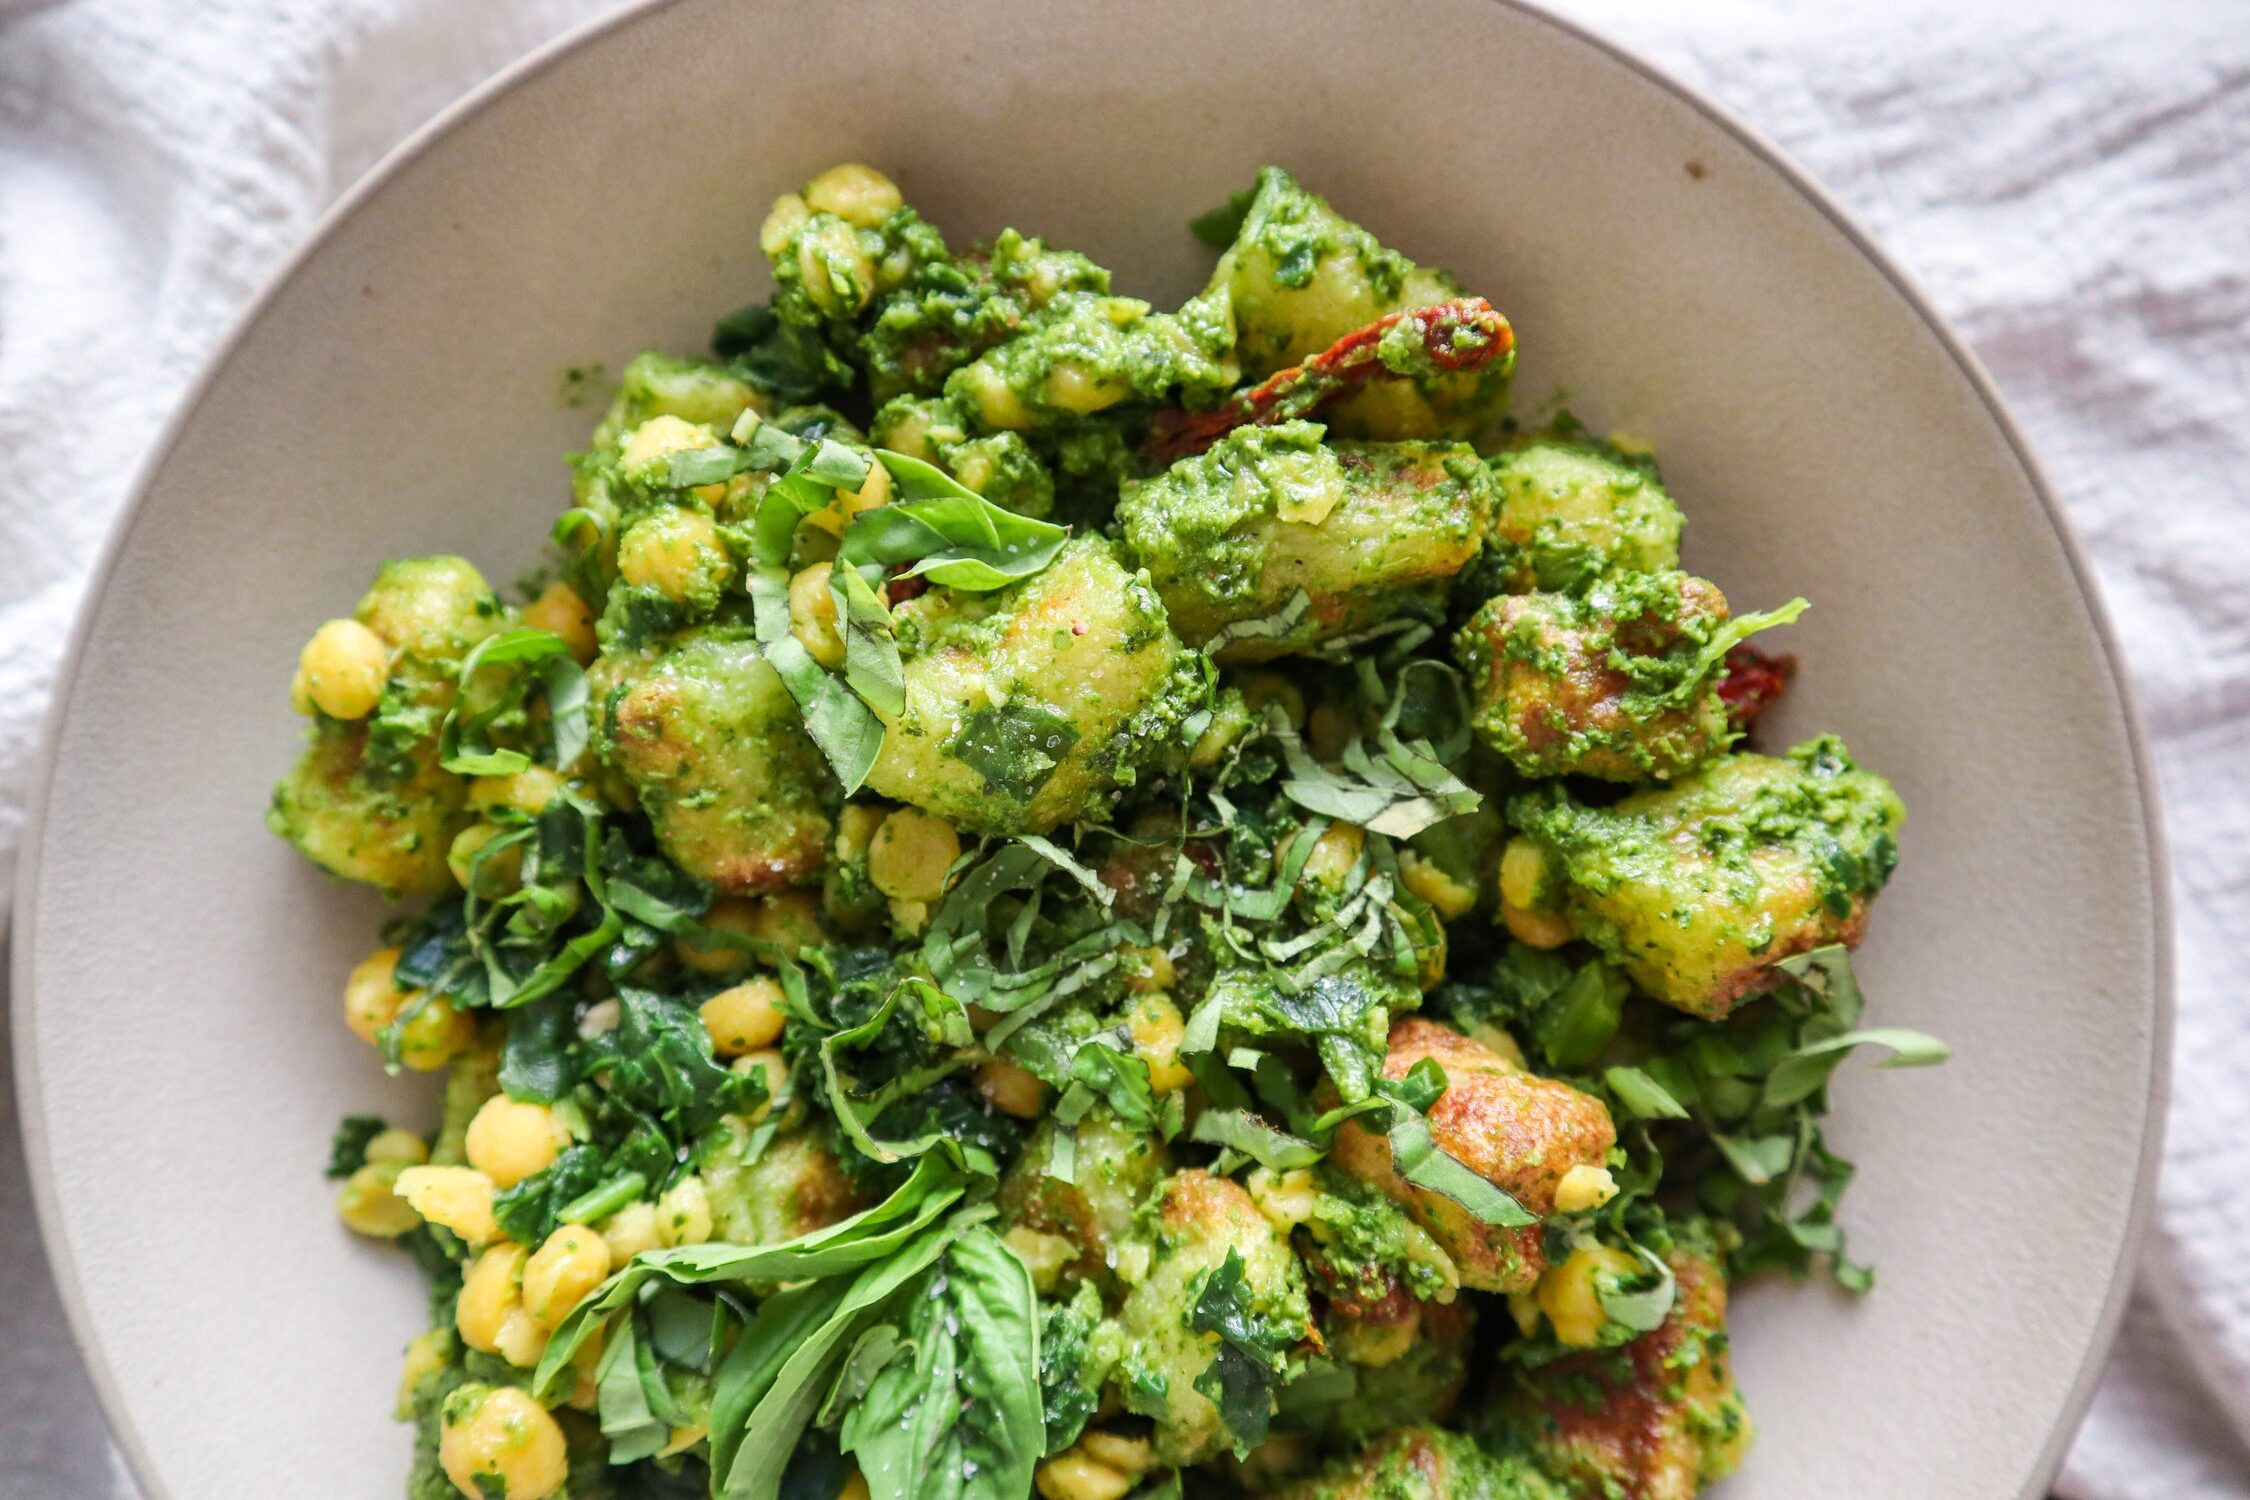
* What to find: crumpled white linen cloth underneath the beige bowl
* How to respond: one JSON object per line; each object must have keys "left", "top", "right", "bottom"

{"left": 0, "top": 0, "right": 2250, "bottom": 1500}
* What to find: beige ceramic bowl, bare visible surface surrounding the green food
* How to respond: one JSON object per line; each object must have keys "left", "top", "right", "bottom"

{"left": 16, "top": 0, "right": 2167, "bottom": 1500}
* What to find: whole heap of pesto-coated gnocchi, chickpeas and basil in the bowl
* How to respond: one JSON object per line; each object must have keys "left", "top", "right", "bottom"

{"left": 285, "top": 162, "right": 1944, "bottom": 1500}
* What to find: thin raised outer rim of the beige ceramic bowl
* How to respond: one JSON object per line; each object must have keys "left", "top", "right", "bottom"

{"left": 0, "top": 0, "right": 2176, "bottom": 1500}
